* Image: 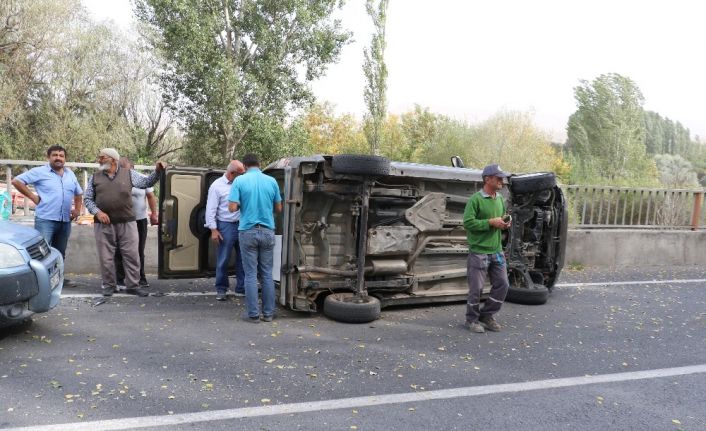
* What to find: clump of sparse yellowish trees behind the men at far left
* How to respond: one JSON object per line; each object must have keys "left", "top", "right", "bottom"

{"left": 0, "top": 0, "right": 178, "bottom": 164}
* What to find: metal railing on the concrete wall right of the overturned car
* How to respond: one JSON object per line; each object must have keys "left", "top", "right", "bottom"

{"left": 562, "top": 185, "right": 706, "bottom": 230}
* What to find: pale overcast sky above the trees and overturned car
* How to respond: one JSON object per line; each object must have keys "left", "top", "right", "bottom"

{"left": 83, "top": 0, "right": 706, "bottom": 141}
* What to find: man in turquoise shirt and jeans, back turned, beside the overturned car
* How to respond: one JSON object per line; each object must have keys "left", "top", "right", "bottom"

{"left": 228, "top": 154, "right": 282, "bottom": 323}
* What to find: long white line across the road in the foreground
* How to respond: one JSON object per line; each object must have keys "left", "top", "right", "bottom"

{"left": 6, "top": 364, "right": 706, "bottom": 431}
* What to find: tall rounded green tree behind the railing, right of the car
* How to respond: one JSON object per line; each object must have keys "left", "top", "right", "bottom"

{"left": 567, "top": 73, "right": 655, "bottom": 183}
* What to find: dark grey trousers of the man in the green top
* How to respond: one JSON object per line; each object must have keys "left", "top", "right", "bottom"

{"left": 466, "top": 253, "right": 510, "bottom": 322}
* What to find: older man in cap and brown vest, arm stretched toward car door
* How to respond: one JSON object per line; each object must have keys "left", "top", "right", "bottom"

{"left": 83, "top": 148, "right": 166, "bottom": 296}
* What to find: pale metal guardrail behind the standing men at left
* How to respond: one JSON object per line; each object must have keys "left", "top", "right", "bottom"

{"left": 0, "top": 159, "right": 154, "bottom": 215}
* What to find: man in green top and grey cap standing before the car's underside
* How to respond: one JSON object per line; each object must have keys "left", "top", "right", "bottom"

{"left": 463, "top": 165, "right": 511, "bottom": 333}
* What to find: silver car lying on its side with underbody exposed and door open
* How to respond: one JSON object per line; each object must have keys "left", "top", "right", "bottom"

{"left": 159, "top": 154, "right": 568, "bottom": 322}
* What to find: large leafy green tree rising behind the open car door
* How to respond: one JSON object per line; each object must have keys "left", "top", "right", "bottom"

{"left": 136, "top": 0, "right": 349, "bottom": 164}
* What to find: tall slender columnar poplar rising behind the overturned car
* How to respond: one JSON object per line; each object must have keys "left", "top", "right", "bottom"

{"left": 363, "top": 0, "right": 388, "bottom": 155}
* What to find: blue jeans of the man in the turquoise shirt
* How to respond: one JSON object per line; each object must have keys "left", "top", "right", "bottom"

{"left": 240, "top": 227, "right": 275, "bottom": 317}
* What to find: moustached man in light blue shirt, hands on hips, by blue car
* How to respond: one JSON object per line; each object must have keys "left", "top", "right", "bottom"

{"left": 12, "top": 145, "right": 83, "bottom": 259}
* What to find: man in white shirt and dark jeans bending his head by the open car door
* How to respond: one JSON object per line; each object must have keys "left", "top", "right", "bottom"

{"left": 205, "top": 160, "right": 245, "bottom": 301}
